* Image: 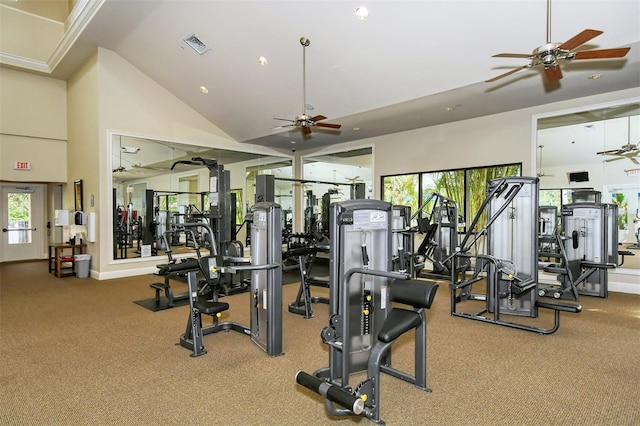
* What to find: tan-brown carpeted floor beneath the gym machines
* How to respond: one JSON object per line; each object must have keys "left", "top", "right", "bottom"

{"left": 0, "top": 262, "right": 640, "bottom": 425}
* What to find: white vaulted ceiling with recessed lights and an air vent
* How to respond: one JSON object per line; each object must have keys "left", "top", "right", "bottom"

{"left": 5, "top": 0, "right": 640, "bottom": 150}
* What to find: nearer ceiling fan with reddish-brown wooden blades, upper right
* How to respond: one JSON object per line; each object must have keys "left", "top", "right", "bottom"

{"left": 486, "top": 0, "right": 630, "bottom": 83}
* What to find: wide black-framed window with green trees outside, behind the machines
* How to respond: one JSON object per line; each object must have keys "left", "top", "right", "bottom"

{"left": 382, "top": 164, "right": 522, "bottom": 230}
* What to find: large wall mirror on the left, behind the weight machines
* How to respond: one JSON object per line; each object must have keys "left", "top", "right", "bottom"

{"left": 109, "top": 133, "right": 293, "bottom": 261}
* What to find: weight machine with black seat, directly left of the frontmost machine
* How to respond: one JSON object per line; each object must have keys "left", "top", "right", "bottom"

{"left": 158, "top": 202, "right": 283, "bottom": 357}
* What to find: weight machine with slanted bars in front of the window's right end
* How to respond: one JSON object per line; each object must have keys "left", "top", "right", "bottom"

{"left": 450, "top": 177, "right": 582, "bottom": 334}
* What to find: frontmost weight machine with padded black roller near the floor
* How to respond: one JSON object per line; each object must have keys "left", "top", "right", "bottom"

{"left": 296, "top": 200, "right": 438, "bottom": 424}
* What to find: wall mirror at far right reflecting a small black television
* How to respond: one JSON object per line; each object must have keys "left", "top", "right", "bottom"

{"left": 534, "top": 99, "right": 640, "bottom": 269}
